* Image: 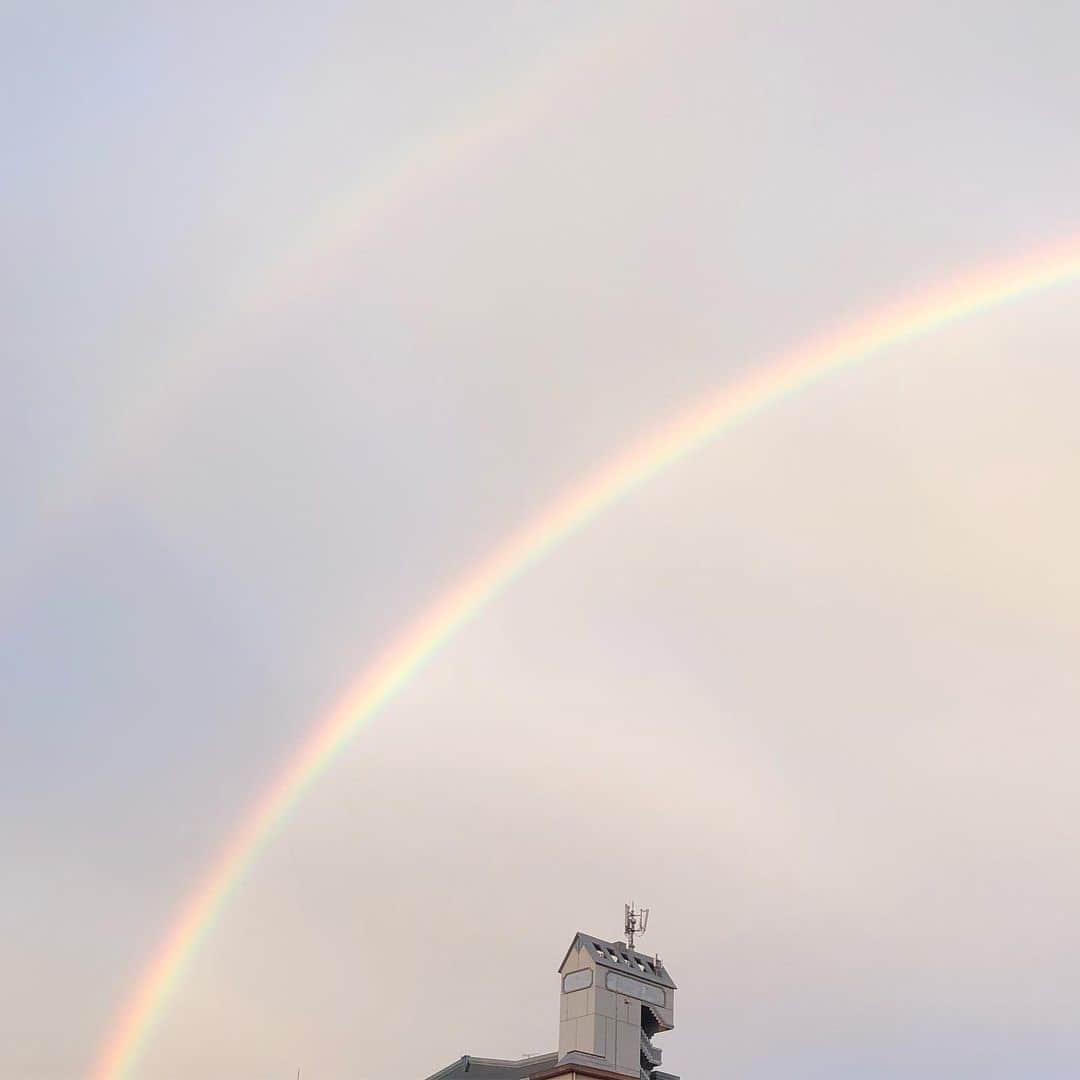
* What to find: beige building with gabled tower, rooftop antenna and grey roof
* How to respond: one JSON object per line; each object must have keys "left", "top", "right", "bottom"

{"left": 428, "top": 924, "right": 679, "bottom": 1080}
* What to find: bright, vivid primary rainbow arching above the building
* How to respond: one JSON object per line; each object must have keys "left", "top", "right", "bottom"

{"left": 94, "top": 241, "right": 1080, "bottom": 1080}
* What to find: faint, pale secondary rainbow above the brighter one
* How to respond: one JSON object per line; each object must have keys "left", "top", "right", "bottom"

{"left": 10, "top": 10, "right": 639, "bottom": 589}
